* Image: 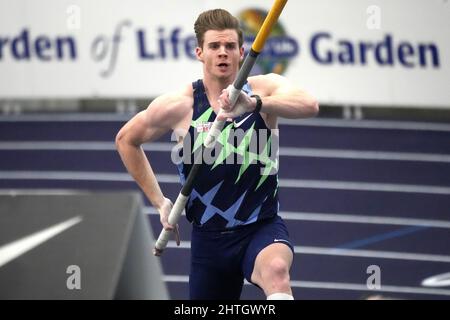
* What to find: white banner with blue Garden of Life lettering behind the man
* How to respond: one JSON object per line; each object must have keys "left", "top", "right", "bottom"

{"left": 0, "top": 0, "right": 450, "bottom": 108}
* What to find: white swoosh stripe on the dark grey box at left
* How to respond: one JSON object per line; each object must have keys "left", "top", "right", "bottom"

{"left": 0, "top": 216, "right": 83, "bottom": 267}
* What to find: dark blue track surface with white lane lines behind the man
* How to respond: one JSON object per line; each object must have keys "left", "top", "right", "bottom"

{"left": 0, "top": 115, "right": 450, "bottom": 299}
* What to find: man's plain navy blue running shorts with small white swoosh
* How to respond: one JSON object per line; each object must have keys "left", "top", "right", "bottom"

{"left": 189, "top": 215, "right": 294, "bottom": 300}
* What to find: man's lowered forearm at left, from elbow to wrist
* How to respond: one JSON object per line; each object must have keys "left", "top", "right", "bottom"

{"left": 117, "top": 142, "right": 164, "bottom": 209}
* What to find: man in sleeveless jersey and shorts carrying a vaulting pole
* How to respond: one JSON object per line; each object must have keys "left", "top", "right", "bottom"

{"left": 116, "top": 9, "right": 319, "bottom": 300}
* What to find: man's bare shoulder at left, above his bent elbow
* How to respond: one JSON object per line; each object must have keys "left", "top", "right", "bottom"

{"left": 145, "top": 85, "right": 194, "bottom": 129}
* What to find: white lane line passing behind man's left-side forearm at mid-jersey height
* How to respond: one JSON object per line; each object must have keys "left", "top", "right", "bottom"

{"left": 0, "top": 171, "right": 450, "bottom": 195}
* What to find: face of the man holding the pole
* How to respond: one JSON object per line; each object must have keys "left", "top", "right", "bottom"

{"left": 196, "top": 29, "right": 244, "bottom": 83}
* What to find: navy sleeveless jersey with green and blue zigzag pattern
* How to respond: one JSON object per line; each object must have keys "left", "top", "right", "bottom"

{"left": 177, "top": 80, "right": 279, "bottom": 230}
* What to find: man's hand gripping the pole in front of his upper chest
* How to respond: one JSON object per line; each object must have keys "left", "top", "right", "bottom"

{"left": 217, "top": 84, "right": 256, "bottom": 120}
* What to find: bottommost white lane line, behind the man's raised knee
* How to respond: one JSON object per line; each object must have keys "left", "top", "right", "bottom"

{"left": 163, "top": 275, "right": 450, "bottom": 296}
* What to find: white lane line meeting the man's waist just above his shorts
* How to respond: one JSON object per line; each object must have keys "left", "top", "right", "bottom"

{"left": 144, "top": 207, "right": 450, "bottom": 229}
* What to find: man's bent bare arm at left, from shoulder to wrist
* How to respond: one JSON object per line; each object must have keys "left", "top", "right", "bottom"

{"left": 116, "top": 88, "right": 193, "bottom": 211}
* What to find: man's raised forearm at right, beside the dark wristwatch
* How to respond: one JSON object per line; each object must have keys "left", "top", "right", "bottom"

{"left": 261, "top": 92, "right": 319, "bottom": 119}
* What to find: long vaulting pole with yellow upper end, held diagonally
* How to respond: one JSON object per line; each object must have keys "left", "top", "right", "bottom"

{"left": 154, "top": 0, "right": 287, "bottom": 256}
